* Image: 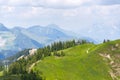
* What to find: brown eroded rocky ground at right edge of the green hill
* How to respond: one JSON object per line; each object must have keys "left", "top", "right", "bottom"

{"left": 99, "top": 43, "right": 120, "bottom": 80}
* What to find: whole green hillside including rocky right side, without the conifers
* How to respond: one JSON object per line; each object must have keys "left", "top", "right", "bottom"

{"left": 33, "top": 40, "right": 120, "bottom": 80}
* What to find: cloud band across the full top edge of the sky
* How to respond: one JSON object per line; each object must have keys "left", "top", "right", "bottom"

{"left": 0, "top": 0, "right": 120, "bottom": 9}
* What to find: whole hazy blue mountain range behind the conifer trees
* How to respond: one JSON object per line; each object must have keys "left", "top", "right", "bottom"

{"left": 0, "top": 24, "right": 76, "bottom": 59}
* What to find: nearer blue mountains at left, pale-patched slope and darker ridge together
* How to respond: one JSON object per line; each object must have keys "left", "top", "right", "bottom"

{"left": 0, "top": 24, "right": 43, "bottom": 59}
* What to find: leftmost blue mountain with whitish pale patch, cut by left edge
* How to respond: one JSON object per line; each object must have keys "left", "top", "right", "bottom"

{"left": 0, "top": 24, "right": 17, "bottom": 59}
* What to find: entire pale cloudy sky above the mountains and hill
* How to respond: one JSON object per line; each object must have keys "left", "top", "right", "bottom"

{"left": 0, "top": 0, "right": 120, "bottom": 40}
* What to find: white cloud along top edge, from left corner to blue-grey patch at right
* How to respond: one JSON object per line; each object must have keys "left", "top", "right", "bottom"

{"left": 0, "top": 0, "right": 92, "bottom": 9}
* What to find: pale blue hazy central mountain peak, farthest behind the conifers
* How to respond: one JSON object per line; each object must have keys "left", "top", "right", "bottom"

{"left": 27, "top": 25, "right": 75, "bottom": 45}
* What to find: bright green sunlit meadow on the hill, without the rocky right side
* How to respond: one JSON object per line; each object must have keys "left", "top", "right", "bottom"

{"left": 34, "top": 44, "right": 112, "bottom": 80}
